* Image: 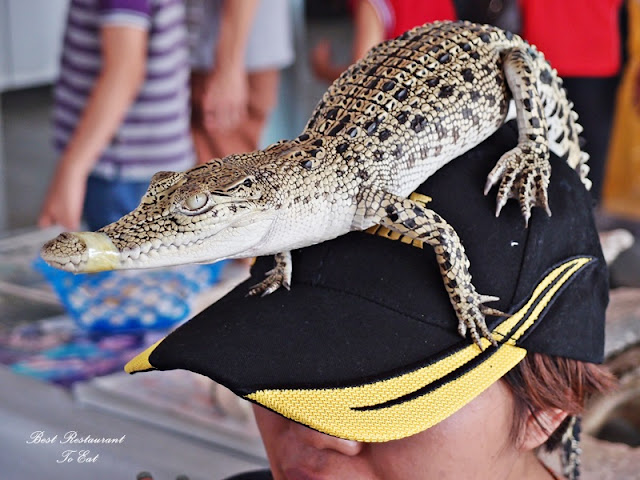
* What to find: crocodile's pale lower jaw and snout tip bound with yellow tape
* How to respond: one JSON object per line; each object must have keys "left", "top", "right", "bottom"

{"left": 40, "top": 219, "right": 272, "bottom": 273}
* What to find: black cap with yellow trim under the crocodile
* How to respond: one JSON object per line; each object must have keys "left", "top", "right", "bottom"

{"left": 126, "top": 125, "right": 608, "bottom": 441}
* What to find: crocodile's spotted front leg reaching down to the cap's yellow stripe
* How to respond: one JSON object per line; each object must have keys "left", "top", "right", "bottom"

{"left": 374, "top": 193, "right": 505, "bottom": 349}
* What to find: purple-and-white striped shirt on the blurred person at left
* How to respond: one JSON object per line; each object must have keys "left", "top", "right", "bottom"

{"left": 53, "top": 0, "right": 194, "bottom": 181}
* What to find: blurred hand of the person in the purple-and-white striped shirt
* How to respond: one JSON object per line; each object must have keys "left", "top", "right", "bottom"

{"left": 38, "top": 163, "right": 87, "bottom": 230}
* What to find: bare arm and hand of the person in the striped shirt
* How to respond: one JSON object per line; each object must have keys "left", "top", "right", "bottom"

{"left": 38, "top": 26, "right": 147, "bottom": 230}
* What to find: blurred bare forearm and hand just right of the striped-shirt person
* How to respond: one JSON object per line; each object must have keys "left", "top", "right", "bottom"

{"left": 200, "top": 0, "right": 258, "bottom": 132}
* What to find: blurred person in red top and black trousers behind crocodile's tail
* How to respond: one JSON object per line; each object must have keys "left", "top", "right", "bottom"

{"left": 520, "top": 0, "right": 622, "bottom": 202}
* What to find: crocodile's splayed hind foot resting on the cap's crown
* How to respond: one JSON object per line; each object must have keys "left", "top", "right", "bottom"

{"left": 484, "top": 142, "right": 551, "bottom": 224}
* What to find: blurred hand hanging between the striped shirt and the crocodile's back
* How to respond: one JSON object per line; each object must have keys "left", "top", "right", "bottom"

{"left": 200, "top": 68, "right": 249, "bottom": 133}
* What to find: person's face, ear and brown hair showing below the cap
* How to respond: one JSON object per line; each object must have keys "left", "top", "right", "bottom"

{"left": 249, "top": 353, "right": 612, "bottom": 480}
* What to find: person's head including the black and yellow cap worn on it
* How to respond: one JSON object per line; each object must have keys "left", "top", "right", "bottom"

{"left": 127, "top": 122, "right": 610, "bottom": 480}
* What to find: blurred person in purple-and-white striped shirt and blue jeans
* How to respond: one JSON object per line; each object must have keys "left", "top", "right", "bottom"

{"left": 38, "top": 0, "right": 194, "bottom": 230}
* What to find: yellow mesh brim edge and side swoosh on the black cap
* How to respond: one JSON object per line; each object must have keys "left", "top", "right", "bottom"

{"left": 246, "top": 258, "right": 591, "bottom": 442}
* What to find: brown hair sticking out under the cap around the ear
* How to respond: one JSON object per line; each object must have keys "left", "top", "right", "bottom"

{"left": 502, "top": 353, "right": 616, "bottom": 451}
